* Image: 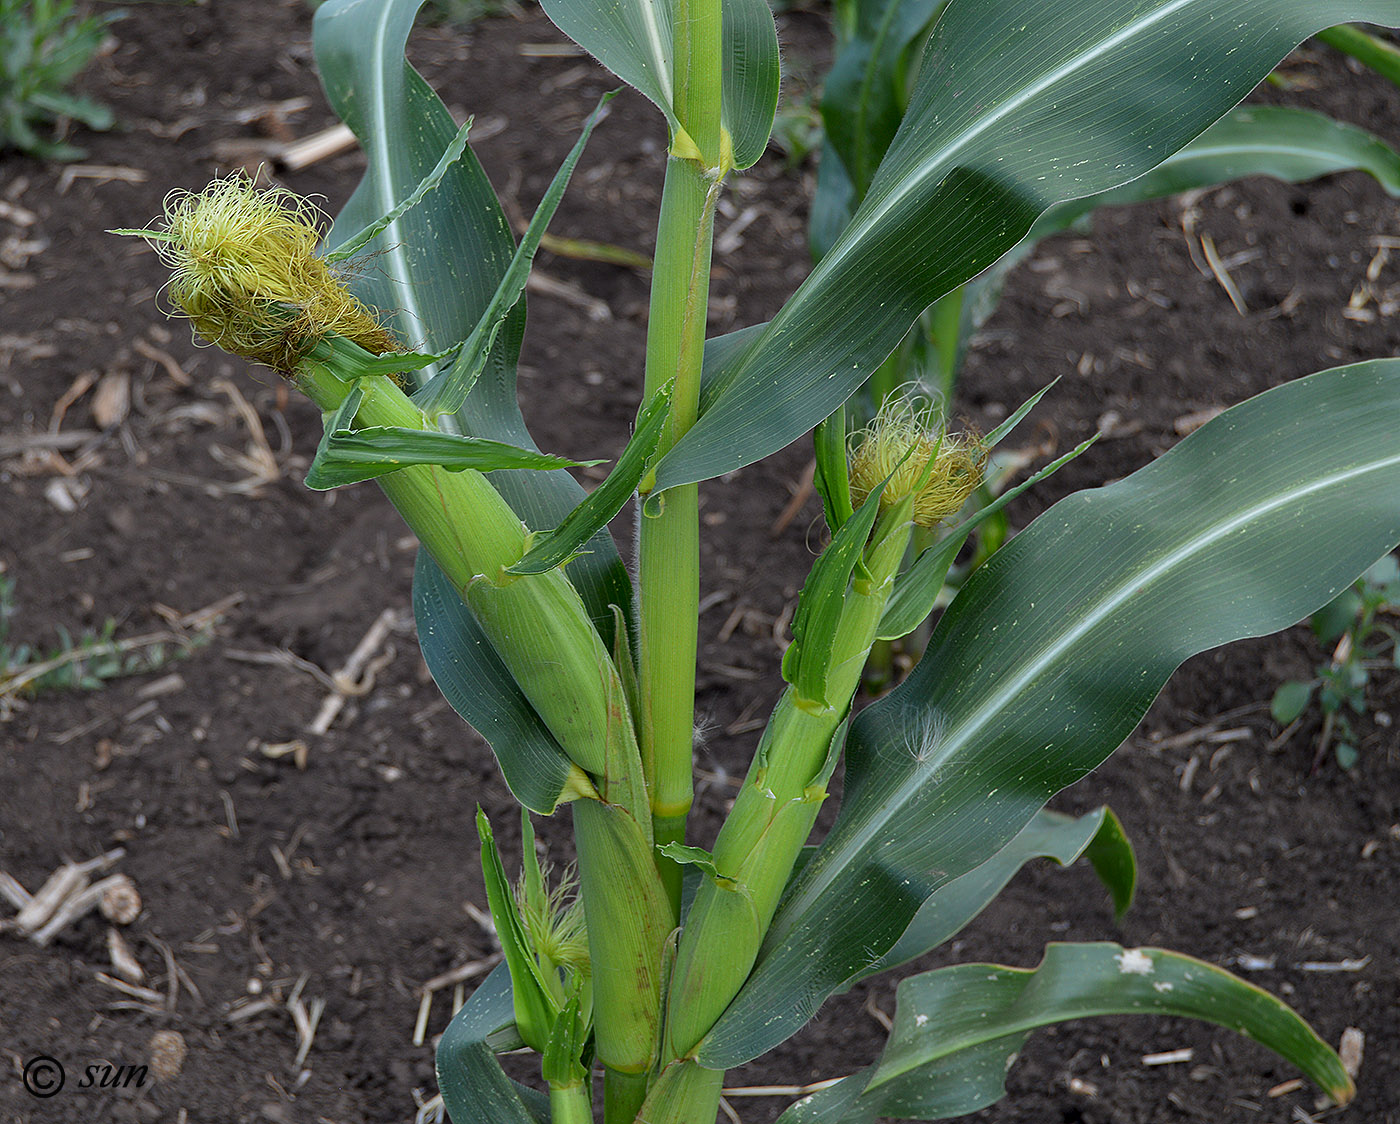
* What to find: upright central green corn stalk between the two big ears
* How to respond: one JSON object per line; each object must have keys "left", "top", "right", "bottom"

{"left": 637, "top": 0, "right": 725, "bottom": 915}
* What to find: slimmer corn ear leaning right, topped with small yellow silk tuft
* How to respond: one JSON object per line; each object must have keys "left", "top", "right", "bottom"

{"left": 662, "top": 403, "right": 987, "bottom": 1062}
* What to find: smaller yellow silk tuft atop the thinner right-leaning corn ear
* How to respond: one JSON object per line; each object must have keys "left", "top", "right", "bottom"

{"left": 851, "top": 399, "right": 990, "bottom": 529}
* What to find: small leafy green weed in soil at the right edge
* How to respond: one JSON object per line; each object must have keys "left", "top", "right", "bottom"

{"left": 1268, "top": 554, "right": 1400, "bottom": 768}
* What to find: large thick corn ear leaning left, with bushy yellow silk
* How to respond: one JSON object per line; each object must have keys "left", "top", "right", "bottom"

{"left": 123, "top": 175, "right": 641, "bottom": 803}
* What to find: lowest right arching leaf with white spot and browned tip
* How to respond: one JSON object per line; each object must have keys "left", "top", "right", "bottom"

{"left": 778, "top": 943, "right": 1355, "bottom": 1124}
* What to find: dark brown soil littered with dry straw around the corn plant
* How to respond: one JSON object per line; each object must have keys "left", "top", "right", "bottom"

{"left": 0, "top": 0, "right": 1400, "bottom": 1124}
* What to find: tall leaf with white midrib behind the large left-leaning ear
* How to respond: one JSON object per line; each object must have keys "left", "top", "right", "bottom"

{"left": 314, "top": 0, "right": 633, "bottom": 671}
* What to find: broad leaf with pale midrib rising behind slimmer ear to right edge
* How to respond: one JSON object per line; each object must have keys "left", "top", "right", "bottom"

{"left": 700, "top": 360, "right": 1400, "bottom": 1068}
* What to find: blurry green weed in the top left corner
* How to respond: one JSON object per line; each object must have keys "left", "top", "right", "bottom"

{"left": 0, "top": 0, "right": 122, "bottom": 160}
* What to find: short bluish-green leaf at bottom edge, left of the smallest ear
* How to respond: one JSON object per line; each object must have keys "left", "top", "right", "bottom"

{"left": 437, "top": 963, "right": 549, "bottom": 1124}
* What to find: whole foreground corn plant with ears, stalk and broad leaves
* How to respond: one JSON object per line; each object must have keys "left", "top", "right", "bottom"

{"left": 117, "top": 0, "right": 1400, "bottom": 1124}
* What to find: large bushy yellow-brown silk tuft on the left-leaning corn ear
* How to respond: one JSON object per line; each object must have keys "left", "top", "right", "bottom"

{"left": 151, "top": 174, "right": 403, "bottom": 374}
